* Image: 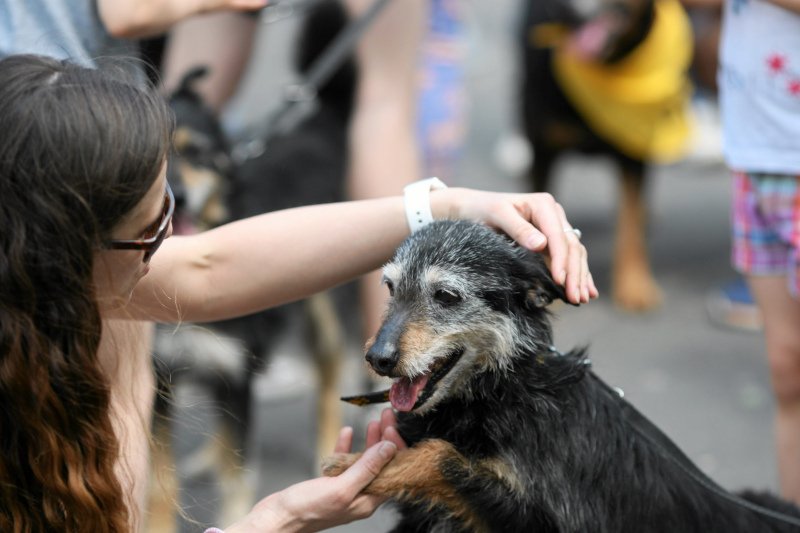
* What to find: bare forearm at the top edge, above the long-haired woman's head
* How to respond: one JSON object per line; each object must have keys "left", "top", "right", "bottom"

{"left": 97, "top": 0, "right": 268, "bottom": 39}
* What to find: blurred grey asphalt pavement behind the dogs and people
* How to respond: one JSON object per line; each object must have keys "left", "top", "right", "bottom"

{"left": 167, "top": 0, "right": 777, "bottom": 532}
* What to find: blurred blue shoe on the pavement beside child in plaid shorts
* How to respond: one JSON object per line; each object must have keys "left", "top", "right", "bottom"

{"left": 706, "top": 277, "right": 764, "bottom": 331}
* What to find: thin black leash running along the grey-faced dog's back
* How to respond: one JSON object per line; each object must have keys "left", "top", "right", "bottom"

{"left": 589, "top": 372, "right": 800, "bottom": 527}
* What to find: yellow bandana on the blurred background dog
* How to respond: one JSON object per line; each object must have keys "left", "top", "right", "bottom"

{"left": 553, "top": 0, "right": 692, "bottom": 162}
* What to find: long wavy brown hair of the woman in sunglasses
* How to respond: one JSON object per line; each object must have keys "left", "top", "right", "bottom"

{"left": 0, "top": 55, "right": 172, "bottom": 533}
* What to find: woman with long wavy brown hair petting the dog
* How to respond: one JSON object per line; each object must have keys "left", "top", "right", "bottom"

{"left": 0, "top": 55, "right": 597, "bottom": 532}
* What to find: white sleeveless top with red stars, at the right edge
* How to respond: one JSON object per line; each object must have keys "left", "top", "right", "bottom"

{"left": 718, "top": 0, "right": 800, "bottom": 175}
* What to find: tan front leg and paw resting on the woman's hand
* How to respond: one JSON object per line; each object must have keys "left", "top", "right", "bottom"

{"left": 322, "top": 439, "right": 490, "bottom": 533}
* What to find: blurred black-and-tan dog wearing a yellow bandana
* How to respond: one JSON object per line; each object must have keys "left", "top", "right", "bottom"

{"left": 520, "top": 0, "right": 692, "bottom": 311}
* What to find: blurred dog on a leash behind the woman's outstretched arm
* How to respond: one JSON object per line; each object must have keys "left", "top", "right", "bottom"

{"left": 150, "top": 0, "right": 356, "bottom": 530}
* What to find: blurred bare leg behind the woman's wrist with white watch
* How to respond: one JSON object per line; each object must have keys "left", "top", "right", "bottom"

{"left": 344, "top": 0, "right": 428, "bottom": 340}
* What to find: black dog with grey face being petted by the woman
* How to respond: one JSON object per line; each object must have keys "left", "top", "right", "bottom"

{"left": 325, "top": 218, "right": 800, "bottom": 533}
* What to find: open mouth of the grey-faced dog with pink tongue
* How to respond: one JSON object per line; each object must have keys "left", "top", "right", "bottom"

{"left": 342, "top": 348, "right": 464, "bottom": 412}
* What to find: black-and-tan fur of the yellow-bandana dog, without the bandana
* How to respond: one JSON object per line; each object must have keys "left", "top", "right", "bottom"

{"left": 519, "top": 0, "right": 689, "bottom": 311}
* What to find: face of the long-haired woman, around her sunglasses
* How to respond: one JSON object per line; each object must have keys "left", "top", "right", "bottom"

{"left": 94, "top": 162, "right": 172, "bottom": 310}
